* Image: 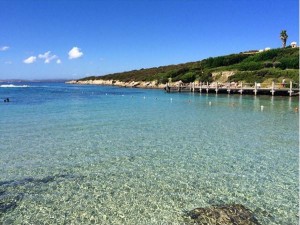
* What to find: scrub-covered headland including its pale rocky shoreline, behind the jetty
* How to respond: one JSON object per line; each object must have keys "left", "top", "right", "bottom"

{"left": 67, "top": 46, "right": 299, "bottom": 94}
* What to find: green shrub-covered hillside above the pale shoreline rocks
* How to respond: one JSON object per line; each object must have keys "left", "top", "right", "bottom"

{"left": 80, "top": 47, "right": 299, "bottom": 84}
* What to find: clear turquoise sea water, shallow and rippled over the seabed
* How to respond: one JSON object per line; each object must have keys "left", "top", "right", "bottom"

{"left": 0, "top": 83, "right": 299, "bottom": 225}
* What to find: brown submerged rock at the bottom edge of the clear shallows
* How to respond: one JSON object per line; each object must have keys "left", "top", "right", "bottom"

{"left": 187, "top": 204, "right": 260, "bottom": 225}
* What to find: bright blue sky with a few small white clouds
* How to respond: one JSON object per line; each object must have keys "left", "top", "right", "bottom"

{"left": 0, "top": 0, "right": 299, "bottom": 80}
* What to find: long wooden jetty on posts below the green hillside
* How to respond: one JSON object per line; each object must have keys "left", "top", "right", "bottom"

{"left": 164, "top": 81, "right": 299, "bottom": 96}
